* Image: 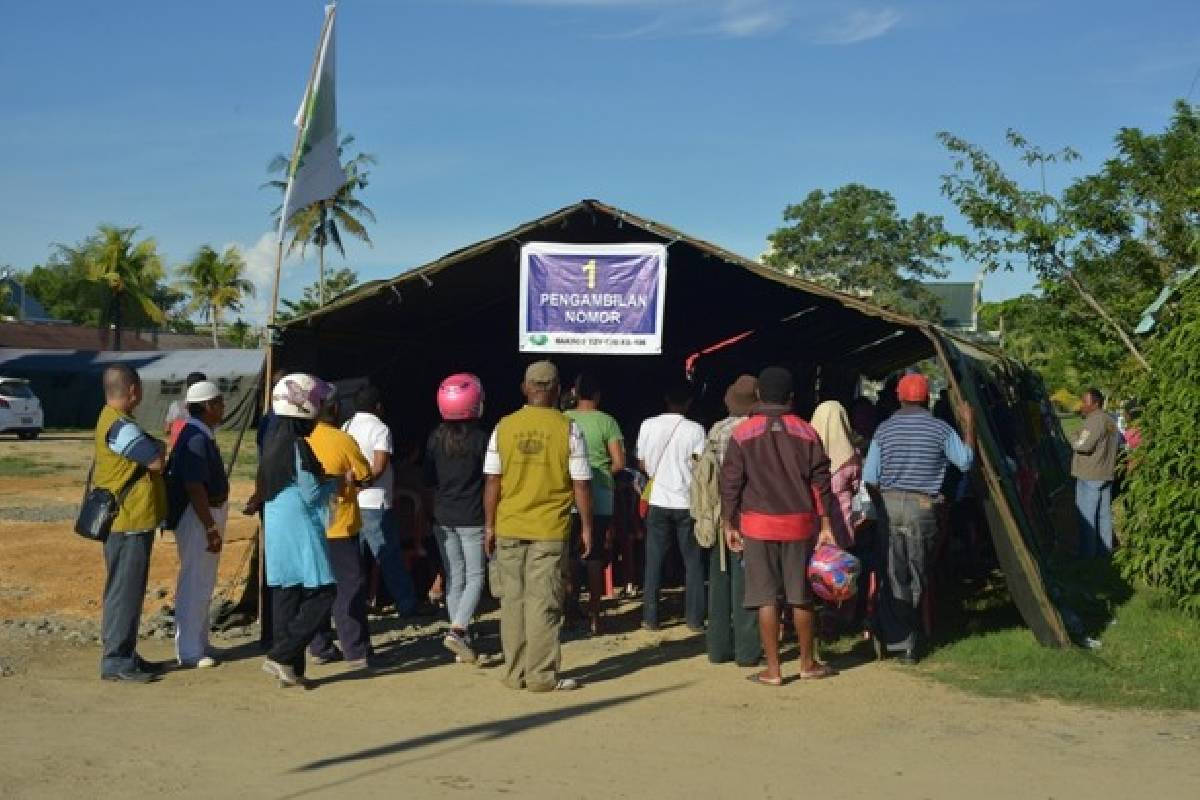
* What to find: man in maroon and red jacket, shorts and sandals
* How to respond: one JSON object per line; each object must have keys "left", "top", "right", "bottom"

{"left": 721, "top": 367, "right": 838, "bottom": 686}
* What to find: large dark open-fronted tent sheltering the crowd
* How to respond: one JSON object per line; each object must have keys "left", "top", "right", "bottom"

{"left": 275, "top": 200, "right": 1069, "bottom": 646}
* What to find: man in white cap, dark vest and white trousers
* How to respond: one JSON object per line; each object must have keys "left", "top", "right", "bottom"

{"left": 167, "top": 380, "right": 229, "bottom": 668}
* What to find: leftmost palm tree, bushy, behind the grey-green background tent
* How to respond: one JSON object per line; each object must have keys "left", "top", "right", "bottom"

{"left": 58, "top": 225, "right": 164, "bottom": 350}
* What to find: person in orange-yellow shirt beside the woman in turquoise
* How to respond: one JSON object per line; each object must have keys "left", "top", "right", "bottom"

{"left": 308, "top": 402, "right": 371, "bottom": 669}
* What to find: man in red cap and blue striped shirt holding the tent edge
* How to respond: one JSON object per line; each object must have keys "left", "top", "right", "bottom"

{"left": 863, "top": 374, "right": 974, "bottom": 664}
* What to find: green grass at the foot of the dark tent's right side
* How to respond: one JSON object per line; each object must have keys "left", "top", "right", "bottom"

{"left": 920, "top": 564, "right": 1200, "bottom": 710}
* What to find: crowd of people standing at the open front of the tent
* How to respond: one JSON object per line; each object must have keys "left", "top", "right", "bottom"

{"left": 87, "top": 361, "right": 993, "bottom": 692}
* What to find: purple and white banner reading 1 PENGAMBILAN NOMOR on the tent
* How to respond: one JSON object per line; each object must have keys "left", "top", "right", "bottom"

{"left": 520, "top": 242, "right": 667, "bottom": 355}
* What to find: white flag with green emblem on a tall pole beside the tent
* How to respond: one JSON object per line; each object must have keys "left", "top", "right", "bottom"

{"left": 280, "top": 4, "right": 346, "bottom": 241}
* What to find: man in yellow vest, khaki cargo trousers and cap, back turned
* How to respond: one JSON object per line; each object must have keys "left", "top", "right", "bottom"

{"left": 484, "top": 361, "right": 592, "bottom": 692}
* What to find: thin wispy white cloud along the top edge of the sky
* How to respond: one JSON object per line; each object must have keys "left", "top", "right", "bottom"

{"left": 486, "top": 0, "right": 901, "bottom": 44}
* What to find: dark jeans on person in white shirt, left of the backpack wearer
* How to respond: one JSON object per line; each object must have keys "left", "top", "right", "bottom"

{"left": 642, "top": 506, "right": 704, "bottom": 631}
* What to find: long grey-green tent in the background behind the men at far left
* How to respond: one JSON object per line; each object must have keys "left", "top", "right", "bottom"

{"left": 0, "top": 349, "right": 264, "bottom": 432}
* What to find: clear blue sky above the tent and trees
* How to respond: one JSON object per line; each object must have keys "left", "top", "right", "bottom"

{"left": 0, "top": 0, "right": 1200, "bottom": 317}
